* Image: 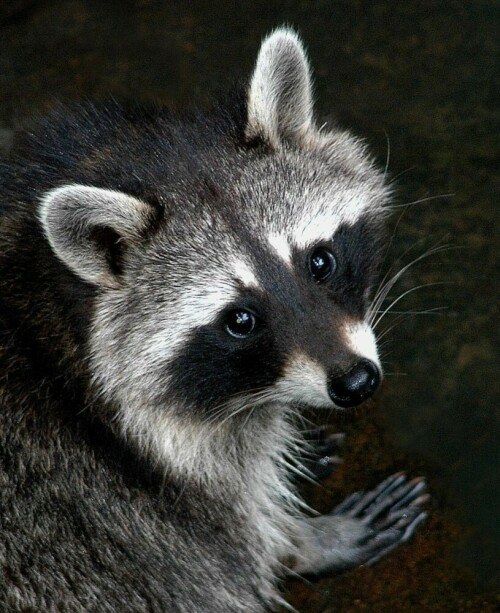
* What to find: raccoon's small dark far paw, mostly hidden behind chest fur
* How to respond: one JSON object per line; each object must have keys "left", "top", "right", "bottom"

{"left": 302, "top": 428, "right": 345, "bottom": 481}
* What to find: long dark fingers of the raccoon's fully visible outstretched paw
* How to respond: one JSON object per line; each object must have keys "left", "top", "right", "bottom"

{"left": 331, "top": 473, "right": 430, "bottom": 566}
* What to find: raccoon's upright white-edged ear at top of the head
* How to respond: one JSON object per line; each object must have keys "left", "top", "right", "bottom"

{"left": 245, "top": 28, "right": 313, "bottom": 148}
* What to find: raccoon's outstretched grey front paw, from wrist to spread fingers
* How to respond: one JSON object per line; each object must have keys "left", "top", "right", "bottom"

{"left": 293, "top": 473, "right": 429, "bottom": 574}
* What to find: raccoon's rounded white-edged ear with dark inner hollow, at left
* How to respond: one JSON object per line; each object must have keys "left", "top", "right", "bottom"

{"left": 40, "top": 185, "right": 155, "bottom": 288}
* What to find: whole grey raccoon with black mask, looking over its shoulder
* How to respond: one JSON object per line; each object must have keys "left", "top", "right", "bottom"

{"left": 0, "top": 28, "right": 427, "bottom": 613}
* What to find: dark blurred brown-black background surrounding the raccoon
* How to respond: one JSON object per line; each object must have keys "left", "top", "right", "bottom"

{"left": 0, "top": 0, "right": 500, "bottom": 612}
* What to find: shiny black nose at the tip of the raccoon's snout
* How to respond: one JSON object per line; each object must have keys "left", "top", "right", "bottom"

{"left": 328, "top": 360, "right": 380, "bottom": 408}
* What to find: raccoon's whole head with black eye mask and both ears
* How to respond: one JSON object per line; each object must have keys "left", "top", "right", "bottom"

{"left": 41, "top": 29, "right": 388, "bottom": 460}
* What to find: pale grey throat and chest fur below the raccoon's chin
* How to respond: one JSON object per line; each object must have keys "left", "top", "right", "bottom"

{"left": 113, "top": 396, "right": 301, "bottom": 581}
